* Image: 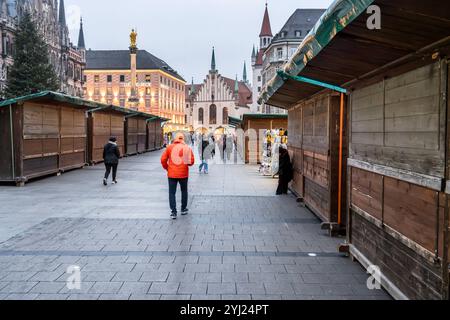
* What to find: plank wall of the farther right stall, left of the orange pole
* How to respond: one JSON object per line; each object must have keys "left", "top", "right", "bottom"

{"left": 289, "top": 91, "right": 347, "bottom": 223}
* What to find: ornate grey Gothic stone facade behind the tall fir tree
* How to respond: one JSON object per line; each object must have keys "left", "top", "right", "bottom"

{"left": 0, "top": 0, "right": 86, "bottom": 97}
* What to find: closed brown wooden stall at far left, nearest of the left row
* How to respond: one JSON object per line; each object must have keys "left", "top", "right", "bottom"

{"left": 0, "top": 91, "right": 94, "bottom": 185}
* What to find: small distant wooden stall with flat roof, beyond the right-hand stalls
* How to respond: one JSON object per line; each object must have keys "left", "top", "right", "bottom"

{"left": 241, "top": 114, "right": 288, "bottom": 163}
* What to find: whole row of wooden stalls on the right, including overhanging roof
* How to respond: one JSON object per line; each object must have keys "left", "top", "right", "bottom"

{"left": 259, "top": 0, "right": 450, "bottom": 300}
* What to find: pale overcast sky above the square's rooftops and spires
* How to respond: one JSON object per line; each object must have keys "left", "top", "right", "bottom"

{"left": 65, "top": 0, "right": 333, "bottom": 83}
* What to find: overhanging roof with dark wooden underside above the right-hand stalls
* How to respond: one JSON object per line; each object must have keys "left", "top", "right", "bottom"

{"left": 259, "top": 0, "right": 450, "bottom": 109}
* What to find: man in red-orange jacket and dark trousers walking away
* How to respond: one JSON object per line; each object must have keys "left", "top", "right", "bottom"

{"left": 161, "top": 133, "right": 195, "bottom": 220}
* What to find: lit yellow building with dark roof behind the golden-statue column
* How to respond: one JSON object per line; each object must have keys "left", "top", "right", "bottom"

{"left": 84, "top": 31, "right": 186, "bottom": 131}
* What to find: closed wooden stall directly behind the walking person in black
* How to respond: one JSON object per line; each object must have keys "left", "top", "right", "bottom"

{"left": 88, "top": 106, "right": 133, "bottom": 164}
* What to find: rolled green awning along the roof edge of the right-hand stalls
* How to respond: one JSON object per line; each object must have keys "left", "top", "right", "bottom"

{"left": 258, "top": 0, "right": 375, "bottom": 104}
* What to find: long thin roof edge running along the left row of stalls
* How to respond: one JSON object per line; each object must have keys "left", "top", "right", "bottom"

{"left": 0, "top": 91, "right": 170, "bottom": 121}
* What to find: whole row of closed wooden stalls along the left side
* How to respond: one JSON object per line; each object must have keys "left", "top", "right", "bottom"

{"left": 0, "top": 91, "right": 167, "bottom": 185}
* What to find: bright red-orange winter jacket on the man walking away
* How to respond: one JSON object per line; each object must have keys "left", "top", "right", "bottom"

{"left": 161, "top": 140, "right": 195, "bottom": 179}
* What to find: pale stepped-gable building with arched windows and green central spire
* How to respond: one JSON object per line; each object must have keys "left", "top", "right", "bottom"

{"left": 186, "top": 49, "right": 253, "bottom": 132}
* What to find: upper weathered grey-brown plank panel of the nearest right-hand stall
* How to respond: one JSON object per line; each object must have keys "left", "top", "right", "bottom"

{"left": 350, "top": 64, "right": 445, "bottom": 177}
